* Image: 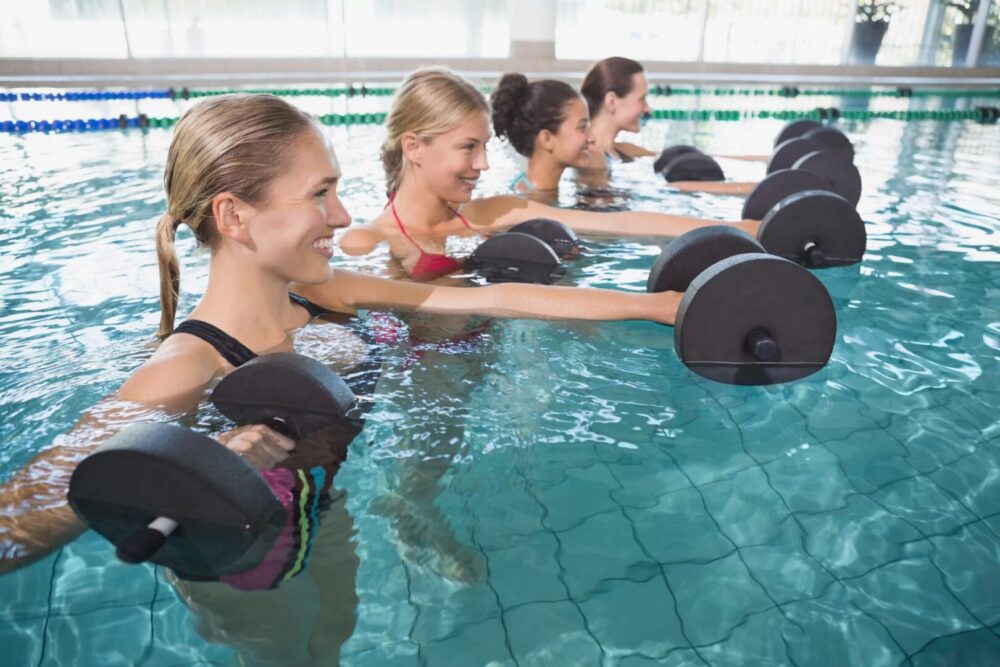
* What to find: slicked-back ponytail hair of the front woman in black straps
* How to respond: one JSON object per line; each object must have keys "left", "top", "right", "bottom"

{"left": 156, "top": 94, "right": 318, "bottom": 338}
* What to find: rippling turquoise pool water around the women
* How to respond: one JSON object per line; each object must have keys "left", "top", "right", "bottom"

{"left": 0, "top": 96, "right": 1000, "bottom": 667}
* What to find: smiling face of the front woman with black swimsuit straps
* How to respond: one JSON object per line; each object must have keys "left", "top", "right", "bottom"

{"left": 249, "top": 131, "right": 351, "bottom": 284}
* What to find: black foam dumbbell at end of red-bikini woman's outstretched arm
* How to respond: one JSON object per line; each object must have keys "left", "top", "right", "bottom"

{"left": 743, "top": 169, "right": 868, "bottom": 269}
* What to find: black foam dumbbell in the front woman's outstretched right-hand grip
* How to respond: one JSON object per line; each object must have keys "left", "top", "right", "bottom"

{"left": 646, "top": 226, "right": 837, "bottom": 385}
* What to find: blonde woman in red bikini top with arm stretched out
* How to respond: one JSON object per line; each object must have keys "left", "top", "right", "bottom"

{"left": 339, "top": 69, "right": 760, "bottom": 282}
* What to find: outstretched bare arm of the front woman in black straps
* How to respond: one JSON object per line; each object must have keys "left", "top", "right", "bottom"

{"left": 298, "top": 270, "right": 683, "bottom": 325}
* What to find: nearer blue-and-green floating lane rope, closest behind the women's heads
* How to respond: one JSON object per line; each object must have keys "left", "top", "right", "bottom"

{"left": 0, "top": 107, "right": 1000, "bottom": 134}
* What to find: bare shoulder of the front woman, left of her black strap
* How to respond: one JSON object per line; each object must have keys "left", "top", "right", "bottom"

{"left": 118, "top": 334, "right": 223, "bottom": 405}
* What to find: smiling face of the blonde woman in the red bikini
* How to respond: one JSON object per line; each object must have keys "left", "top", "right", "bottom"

{"left": 408, "top": 111, "right": 490, "bottom": 203}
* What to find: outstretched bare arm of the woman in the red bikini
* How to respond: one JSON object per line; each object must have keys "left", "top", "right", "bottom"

{"left": 462, "top": 195, "right": 760, "bottom": 238}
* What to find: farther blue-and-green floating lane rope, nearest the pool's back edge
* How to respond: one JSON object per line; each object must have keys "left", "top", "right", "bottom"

{"left": 0, "top": 85, "right": 1000, "bottom": 102}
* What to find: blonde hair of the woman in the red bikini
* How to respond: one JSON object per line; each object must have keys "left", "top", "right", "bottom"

{"left": 382, "top": 68, "right": 490, "bottom": 195}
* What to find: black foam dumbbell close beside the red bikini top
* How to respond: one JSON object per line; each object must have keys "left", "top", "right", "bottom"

{"left": 466, "top": 218, "right": 580, "bottom": 284}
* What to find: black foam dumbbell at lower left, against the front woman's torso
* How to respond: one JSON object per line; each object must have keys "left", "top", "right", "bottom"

{"left": 68, "top": 353, "right": 361, "bottom": 579}
